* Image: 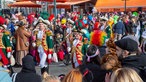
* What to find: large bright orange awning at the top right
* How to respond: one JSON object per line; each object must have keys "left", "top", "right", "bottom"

{"left": 95, "top": 0, "right": 146, "bottom": 12}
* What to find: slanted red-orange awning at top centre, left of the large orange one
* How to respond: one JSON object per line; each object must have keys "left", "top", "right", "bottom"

{"left": 49, "top": 0, "right": 90, "bottom": 9}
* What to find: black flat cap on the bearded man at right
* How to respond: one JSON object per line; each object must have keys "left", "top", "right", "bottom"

{"left": 115, "top": 38, "right": 138, "bottom": 52}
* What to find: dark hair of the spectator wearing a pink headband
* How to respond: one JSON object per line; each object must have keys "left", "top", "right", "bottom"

{"left": 85, "top": 45, "right": 101, "bottom": 65}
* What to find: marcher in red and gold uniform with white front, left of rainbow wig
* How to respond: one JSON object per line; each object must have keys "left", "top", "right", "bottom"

{"left": 72, "top": 32, "right": 83, "bottom": 68}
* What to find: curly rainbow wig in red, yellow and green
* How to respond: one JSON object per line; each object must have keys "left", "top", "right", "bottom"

{"left": 90, "top": 30, "right": 107, "bottom": 46}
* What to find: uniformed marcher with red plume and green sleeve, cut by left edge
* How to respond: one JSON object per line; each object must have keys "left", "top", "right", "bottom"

{"left": 0, "top": 16, "right": 12, "bottom": 66}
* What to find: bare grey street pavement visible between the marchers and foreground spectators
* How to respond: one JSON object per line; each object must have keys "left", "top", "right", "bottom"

{"left": 13, "top": 61, "right": 72, "bottom": 76}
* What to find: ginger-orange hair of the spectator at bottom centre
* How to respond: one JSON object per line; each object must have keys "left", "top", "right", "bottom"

{"left": 62, "top": 68, "right": 83, "bottom": 82}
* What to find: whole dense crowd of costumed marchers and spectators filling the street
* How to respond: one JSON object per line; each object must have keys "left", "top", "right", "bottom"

{"left": 0, "top": 11, "right": 146, "bottom": 82}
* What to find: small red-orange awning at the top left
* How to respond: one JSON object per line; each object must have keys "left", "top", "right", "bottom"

{"left": 8, "top": 1, "right": 41, "bottom": 8}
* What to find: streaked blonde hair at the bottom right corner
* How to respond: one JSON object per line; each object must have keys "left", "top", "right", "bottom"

{"left": 110, "top": 68, "right": 143, "bottom": 82}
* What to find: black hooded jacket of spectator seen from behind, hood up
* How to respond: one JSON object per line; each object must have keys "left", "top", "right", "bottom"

{"left": 15, "top": 55, "right": 41, "bottom": 82}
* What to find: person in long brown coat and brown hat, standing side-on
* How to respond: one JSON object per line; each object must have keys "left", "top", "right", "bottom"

{"left": 15, "top": 16, "right": 31, "bottom": 66}
